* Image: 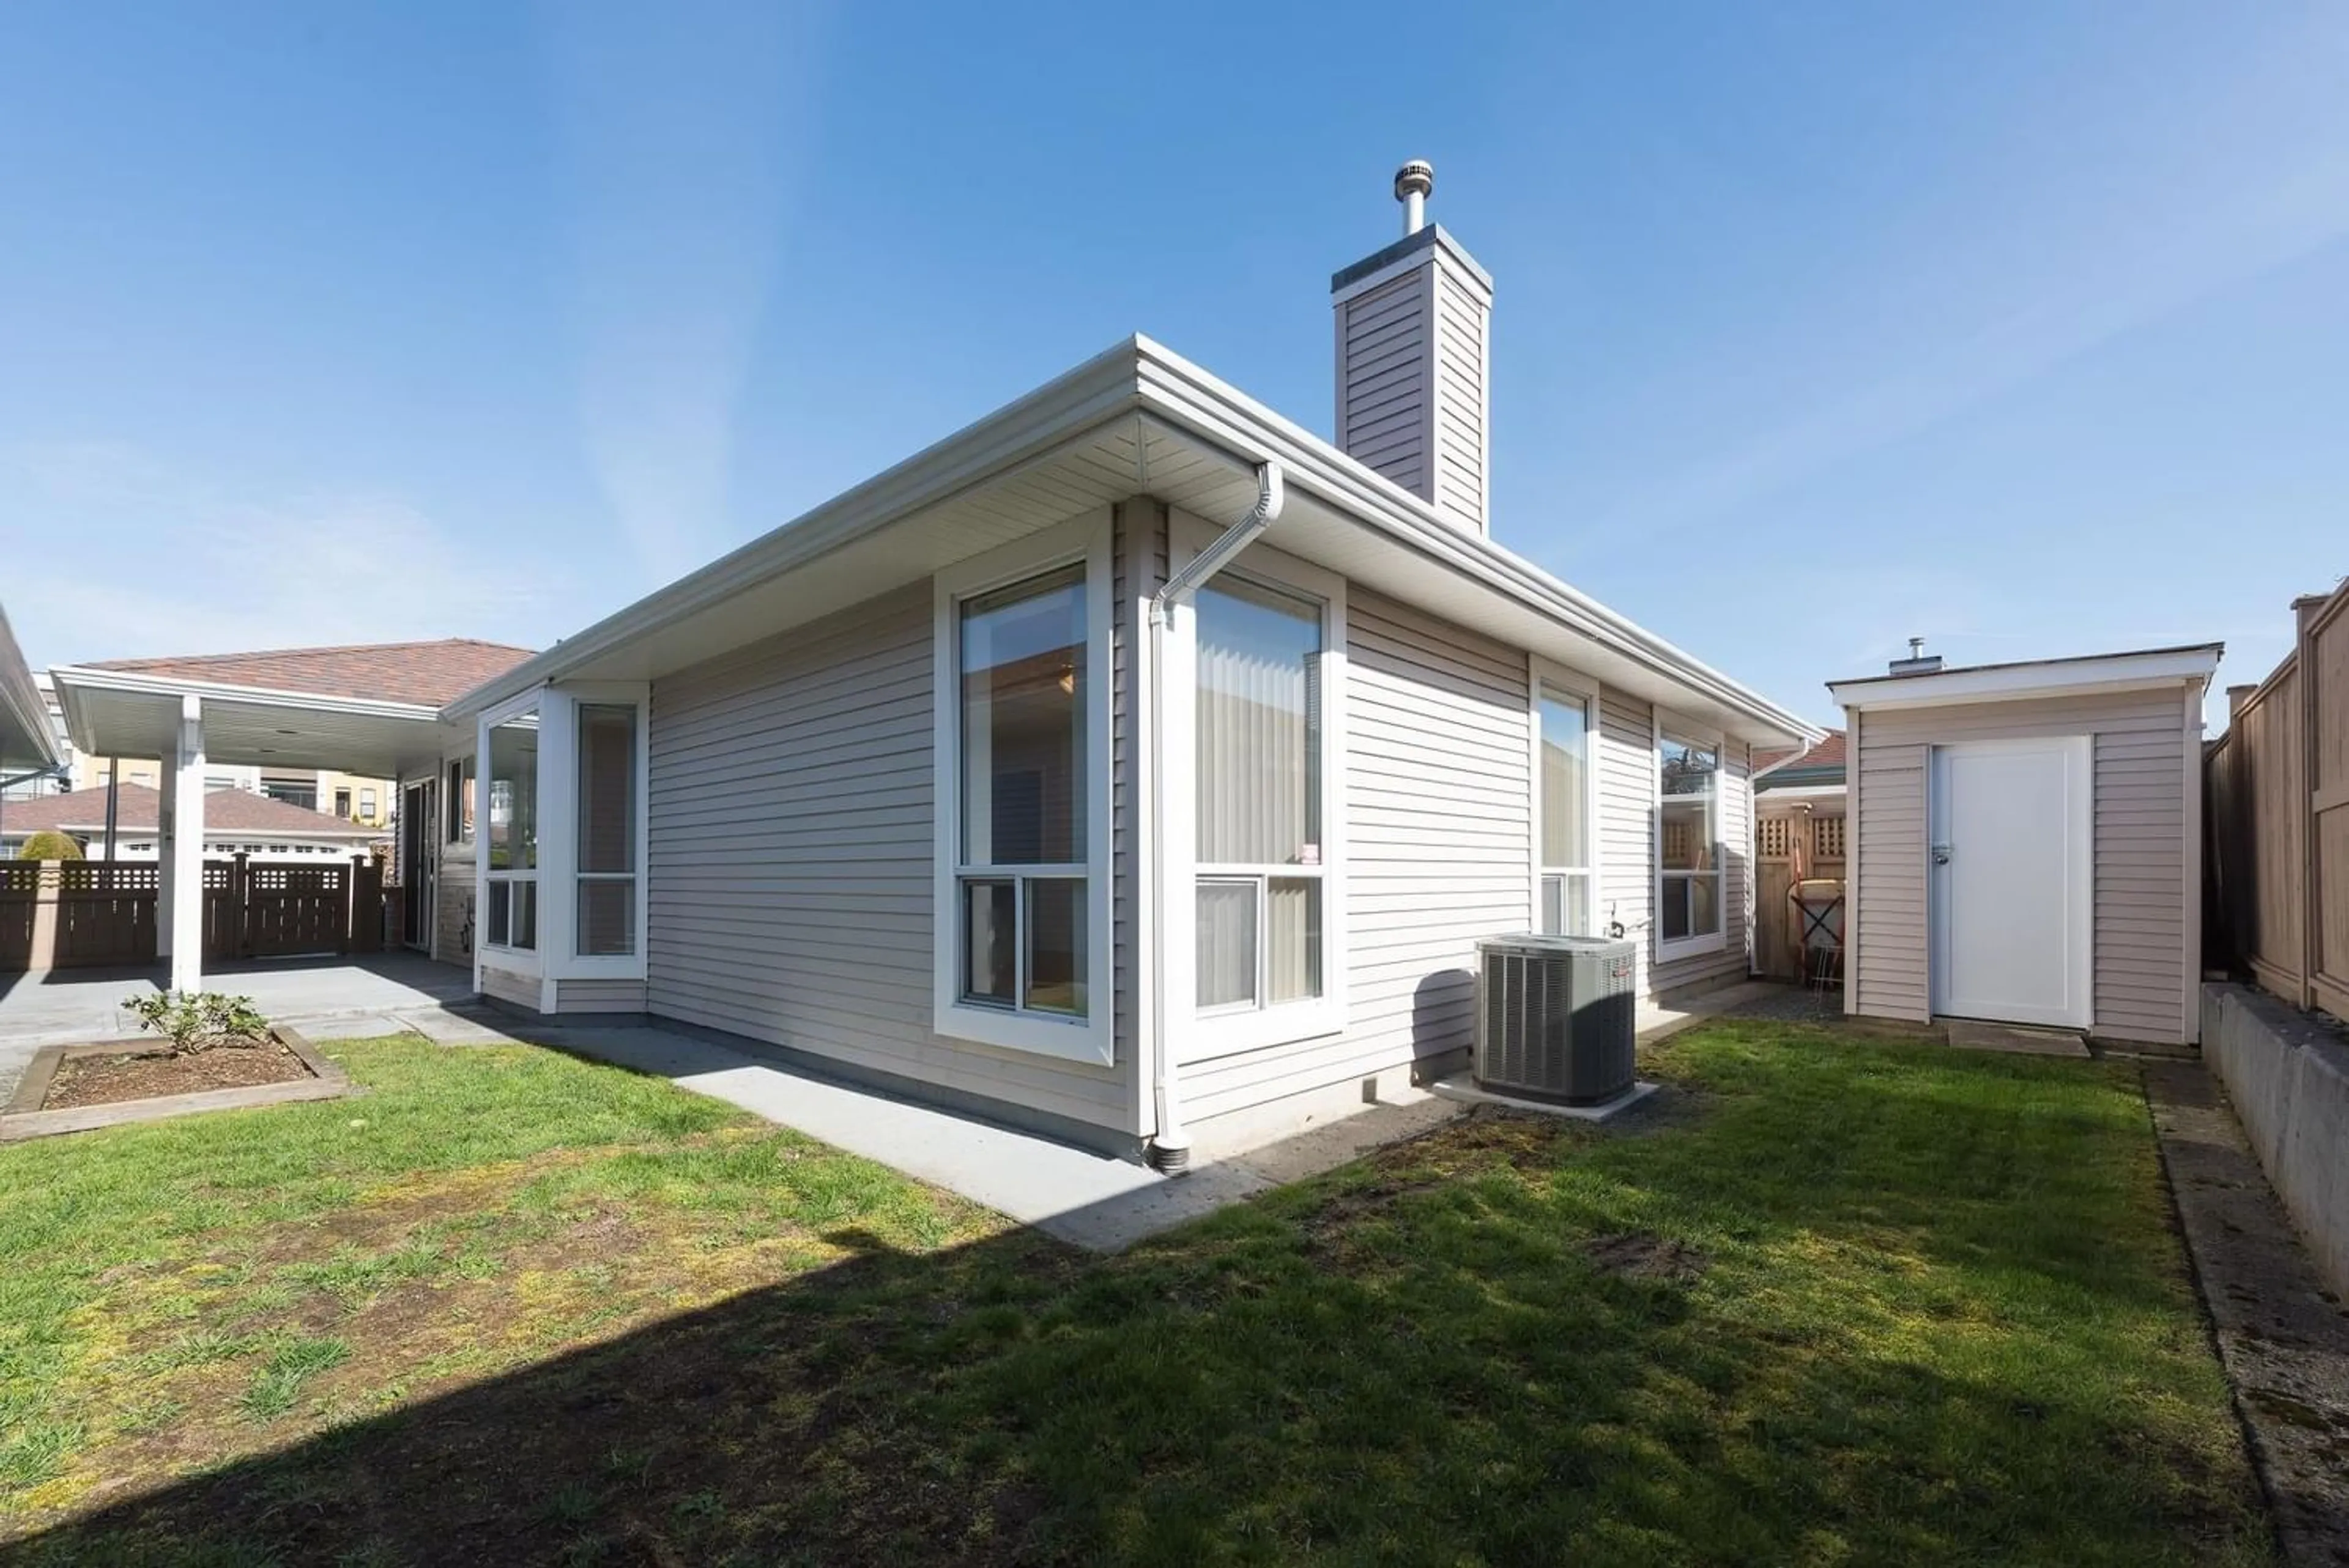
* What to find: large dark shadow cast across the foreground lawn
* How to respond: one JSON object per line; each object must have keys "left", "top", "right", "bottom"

{"left": 0, "top": 1034, "right": 2262, "bottom": 1568}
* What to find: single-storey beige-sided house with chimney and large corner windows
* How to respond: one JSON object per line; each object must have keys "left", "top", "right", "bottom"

{"left": 411, "top": 179, "right": 1816, "bottom": 1157}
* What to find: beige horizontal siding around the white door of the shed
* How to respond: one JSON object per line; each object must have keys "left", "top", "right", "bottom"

{"left": 1856, "top": 686, "right": 2187, "bottom": 1041}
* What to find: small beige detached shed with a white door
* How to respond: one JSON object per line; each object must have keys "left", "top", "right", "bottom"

{"left": 1828, "top": 642, "right": 2222, "bottom": 1044}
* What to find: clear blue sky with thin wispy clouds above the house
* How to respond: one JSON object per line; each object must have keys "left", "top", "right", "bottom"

{"left": 0, "top": 0, "right": 2349, "bottom": 719}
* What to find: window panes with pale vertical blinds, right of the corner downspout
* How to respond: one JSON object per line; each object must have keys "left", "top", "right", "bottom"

{"left": 1193, "top": 582, "right": 1327, "bottom": 1013}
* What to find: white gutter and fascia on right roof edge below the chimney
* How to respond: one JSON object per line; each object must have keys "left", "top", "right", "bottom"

{"left": 1139, "top": 338, "right": 1828, "bottom": 748}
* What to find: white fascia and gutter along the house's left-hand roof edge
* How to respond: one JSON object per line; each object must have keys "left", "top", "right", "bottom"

{"left": 442, "top": 338, "right": 1141, "bottom": 719}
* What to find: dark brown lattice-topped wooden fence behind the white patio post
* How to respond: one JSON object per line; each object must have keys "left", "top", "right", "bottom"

{"left": 0, "top": 856, "right": 383, "bottom": 971}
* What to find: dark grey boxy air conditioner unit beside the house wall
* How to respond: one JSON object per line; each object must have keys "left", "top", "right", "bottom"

{"left": 1475, "top": 935, "right": 1637, "bottom": 1105}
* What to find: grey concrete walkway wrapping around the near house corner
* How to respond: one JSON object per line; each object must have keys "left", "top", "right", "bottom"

{"left": 543, "top": 1027, "right": 1457, "bottom": 1253}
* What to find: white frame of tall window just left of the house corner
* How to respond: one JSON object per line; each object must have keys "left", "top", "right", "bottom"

{"left": 930, "top": 508, "right": 1118, "bottom": 1068}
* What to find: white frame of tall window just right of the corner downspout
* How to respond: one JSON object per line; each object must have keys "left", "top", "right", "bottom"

{"left": 1156, "top": 513, "right": 1348, "bottom": 1063}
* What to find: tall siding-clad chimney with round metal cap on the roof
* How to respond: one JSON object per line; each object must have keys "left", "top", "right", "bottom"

{"left": 1329, "top": 160, "right": 1491, "bottom": 533}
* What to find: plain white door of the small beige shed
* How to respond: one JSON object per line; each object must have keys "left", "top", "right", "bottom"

{"left": 1926, "top": 736, "right": 2095, "bottom": 1030}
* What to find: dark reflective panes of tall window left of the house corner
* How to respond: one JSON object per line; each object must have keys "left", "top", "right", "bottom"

{"left": 956, "top": 567, "right": 1097, "bottom": 1020}
